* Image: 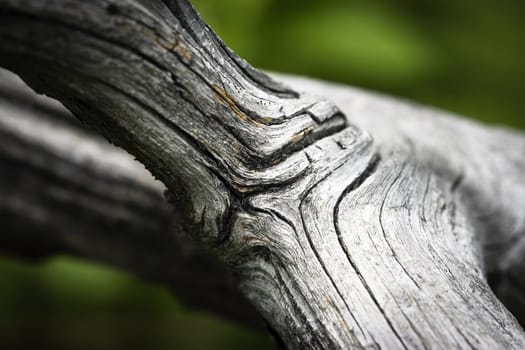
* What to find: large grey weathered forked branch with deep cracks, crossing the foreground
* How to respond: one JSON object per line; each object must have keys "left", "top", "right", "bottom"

{"left": 0, "top": 0, "right": 525, "bottom": 349}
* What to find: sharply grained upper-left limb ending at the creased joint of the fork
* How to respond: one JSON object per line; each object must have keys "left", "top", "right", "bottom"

{"left": 0, "top": 0, "right": 344, "bottom": 244}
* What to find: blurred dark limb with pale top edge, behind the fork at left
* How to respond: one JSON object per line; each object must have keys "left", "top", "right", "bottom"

{"left": 0, "top": 70, "right": 261, "bottom": 326}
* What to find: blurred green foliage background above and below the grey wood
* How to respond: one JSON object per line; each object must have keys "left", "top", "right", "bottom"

{"left": 0, "top": 0, "right": 525, "bottom": 350}
